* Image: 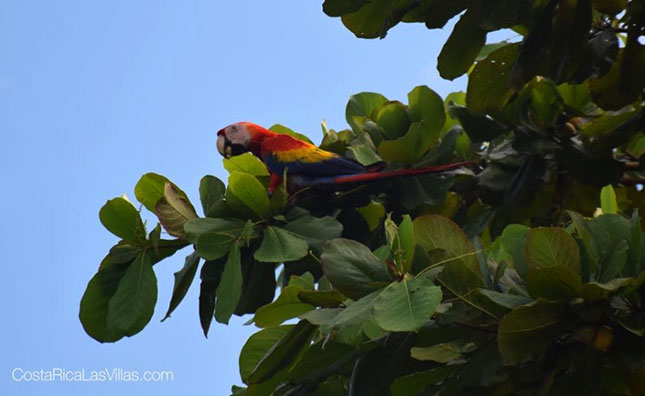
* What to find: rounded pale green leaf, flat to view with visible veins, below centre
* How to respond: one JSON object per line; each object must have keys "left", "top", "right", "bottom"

{"left": 374, "top": 277, "right": 442, "bottom": 331}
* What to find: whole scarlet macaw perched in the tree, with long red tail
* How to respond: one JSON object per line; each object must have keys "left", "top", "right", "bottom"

{"left": 217, "top": 122, "right": 469, "bottom": 194}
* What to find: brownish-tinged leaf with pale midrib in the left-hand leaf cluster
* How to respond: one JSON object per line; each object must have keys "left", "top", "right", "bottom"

{"left": 155, "top": 183, "right": 197, "bottom": 239}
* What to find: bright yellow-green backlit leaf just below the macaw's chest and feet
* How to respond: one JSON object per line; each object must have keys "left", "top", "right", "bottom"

{"left": 226, "top": 172, "right": 271, "bottom": 218}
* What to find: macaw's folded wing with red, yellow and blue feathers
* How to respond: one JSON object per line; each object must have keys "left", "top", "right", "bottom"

{"left": 262, "top": 135, "right": 366, "bottom": 176}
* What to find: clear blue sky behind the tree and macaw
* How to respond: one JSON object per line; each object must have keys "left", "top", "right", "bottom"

{"left": 0, "top": 0, "right": 476, "bottom": 395}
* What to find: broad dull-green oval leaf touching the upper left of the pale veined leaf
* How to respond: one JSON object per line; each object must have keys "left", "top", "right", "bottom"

{"left": 321, "top": 238, "right": 392, "bottom": 300}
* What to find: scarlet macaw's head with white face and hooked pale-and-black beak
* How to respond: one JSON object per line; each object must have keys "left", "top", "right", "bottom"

{"left": 217, "top": 122, "right": 271, "bottom": 158}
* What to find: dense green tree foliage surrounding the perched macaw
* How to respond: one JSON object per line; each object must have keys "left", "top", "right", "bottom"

{"left": 80, "top": 0, "right": 645, "bottom": 395}
